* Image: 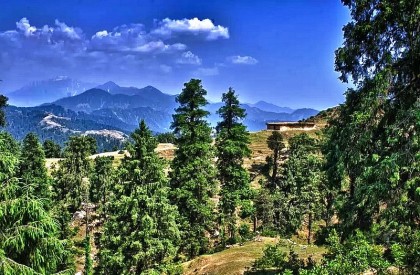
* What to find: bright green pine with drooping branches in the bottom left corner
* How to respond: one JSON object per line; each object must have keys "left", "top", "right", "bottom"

{"left": 0, "top": 132, "right": 72, "bottom": 274}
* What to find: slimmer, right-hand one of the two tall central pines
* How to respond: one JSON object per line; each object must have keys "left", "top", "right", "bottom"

{"left": 216, "top": 88, "right": 251, "bottom": 244}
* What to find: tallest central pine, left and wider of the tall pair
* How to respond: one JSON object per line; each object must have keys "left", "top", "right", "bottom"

{"left": 170, "top": 79, "right": 215, "bottom": 257}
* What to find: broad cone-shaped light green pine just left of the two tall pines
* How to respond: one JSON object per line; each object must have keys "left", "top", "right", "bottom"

{"left": 98, "top": 120, "right": 180, "bottom": 274}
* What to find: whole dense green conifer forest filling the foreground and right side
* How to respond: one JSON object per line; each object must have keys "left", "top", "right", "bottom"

{"left": 0, "top": 0, "right": 420, "bottom": 274}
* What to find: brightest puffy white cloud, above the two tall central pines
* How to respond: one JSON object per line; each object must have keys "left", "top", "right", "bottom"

{"left": 152, "top": 17, "right": 229, "bottom": 40}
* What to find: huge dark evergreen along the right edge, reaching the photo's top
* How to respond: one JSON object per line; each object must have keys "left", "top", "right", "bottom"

{"left": 328, "top": 0, "right": 420, "bottom": 238}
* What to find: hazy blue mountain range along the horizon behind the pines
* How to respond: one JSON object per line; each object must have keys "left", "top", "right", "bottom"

{"left": 2, "top": 77, "right": 318, "bottom": 153}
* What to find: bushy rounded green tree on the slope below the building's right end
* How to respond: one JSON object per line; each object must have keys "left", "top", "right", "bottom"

{"left": 275, "top": 133, "right": 325, "bottom": 243}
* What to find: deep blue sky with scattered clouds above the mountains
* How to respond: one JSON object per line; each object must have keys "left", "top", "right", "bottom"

{"left": 0, "top": 0, "right": 349, "bottom": 109}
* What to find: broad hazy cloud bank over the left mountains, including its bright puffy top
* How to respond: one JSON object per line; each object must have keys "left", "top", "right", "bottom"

{"left": 0, "top": 18, "right": 229, "bottom": 87}
